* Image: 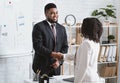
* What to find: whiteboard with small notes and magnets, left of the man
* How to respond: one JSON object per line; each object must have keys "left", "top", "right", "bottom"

{"left": 0, "top": 0, "right": 33, "bottom": 56}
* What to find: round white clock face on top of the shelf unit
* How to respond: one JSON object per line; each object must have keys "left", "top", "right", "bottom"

{"left": 65, "top": 14, "right": 76, "bottom": 26}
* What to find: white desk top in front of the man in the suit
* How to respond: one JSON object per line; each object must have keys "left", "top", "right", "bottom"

{"left": 24, "top": 75, "right": 73, "bottom": 83}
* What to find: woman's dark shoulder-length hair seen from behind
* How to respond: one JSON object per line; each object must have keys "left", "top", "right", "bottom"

{"left": 81, "top": 18, "right": 103, "bottom": 42}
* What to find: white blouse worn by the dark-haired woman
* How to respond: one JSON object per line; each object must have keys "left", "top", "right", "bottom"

{"left": 65, "top": 38, "right": 105, "bottom": 83}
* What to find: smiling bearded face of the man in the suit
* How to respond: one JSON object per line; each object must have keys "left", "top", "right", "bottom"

{"left": 45, "top": 8, "right": 58, "bottom": 23}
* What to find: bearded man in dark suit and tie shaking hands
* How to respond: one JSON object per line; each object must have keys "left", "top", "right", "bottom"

{"left": 32, "top": 3, "right": 68, "bottom": 76}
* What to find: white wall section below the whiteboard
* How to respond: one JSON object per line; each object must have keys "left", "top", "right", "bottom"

{"left": 0, "top": 55, "right": 32, "bottom": 83}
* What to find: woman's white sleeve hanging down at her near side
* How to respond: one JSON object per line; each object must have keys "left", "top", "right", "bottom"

{"left": 75, "top": 43, "right": 90, "bottom": 83}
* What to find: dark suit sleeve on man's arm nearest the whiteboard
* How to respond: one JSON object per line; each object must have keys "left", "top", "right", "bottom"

{"left": 32, "top": 24, "right": 52, "bottom": 55}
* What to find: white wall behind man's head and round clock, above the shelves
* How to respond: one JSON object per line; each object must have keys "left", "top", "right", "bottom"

{"left": 33, "top": 0, "right": 116, "bottom": 23}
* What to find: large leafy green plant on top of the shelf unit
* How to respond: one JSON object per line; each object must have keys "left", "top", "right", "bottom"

{"left": 91, "top": 5, "right": 116, "bottom": 20}
